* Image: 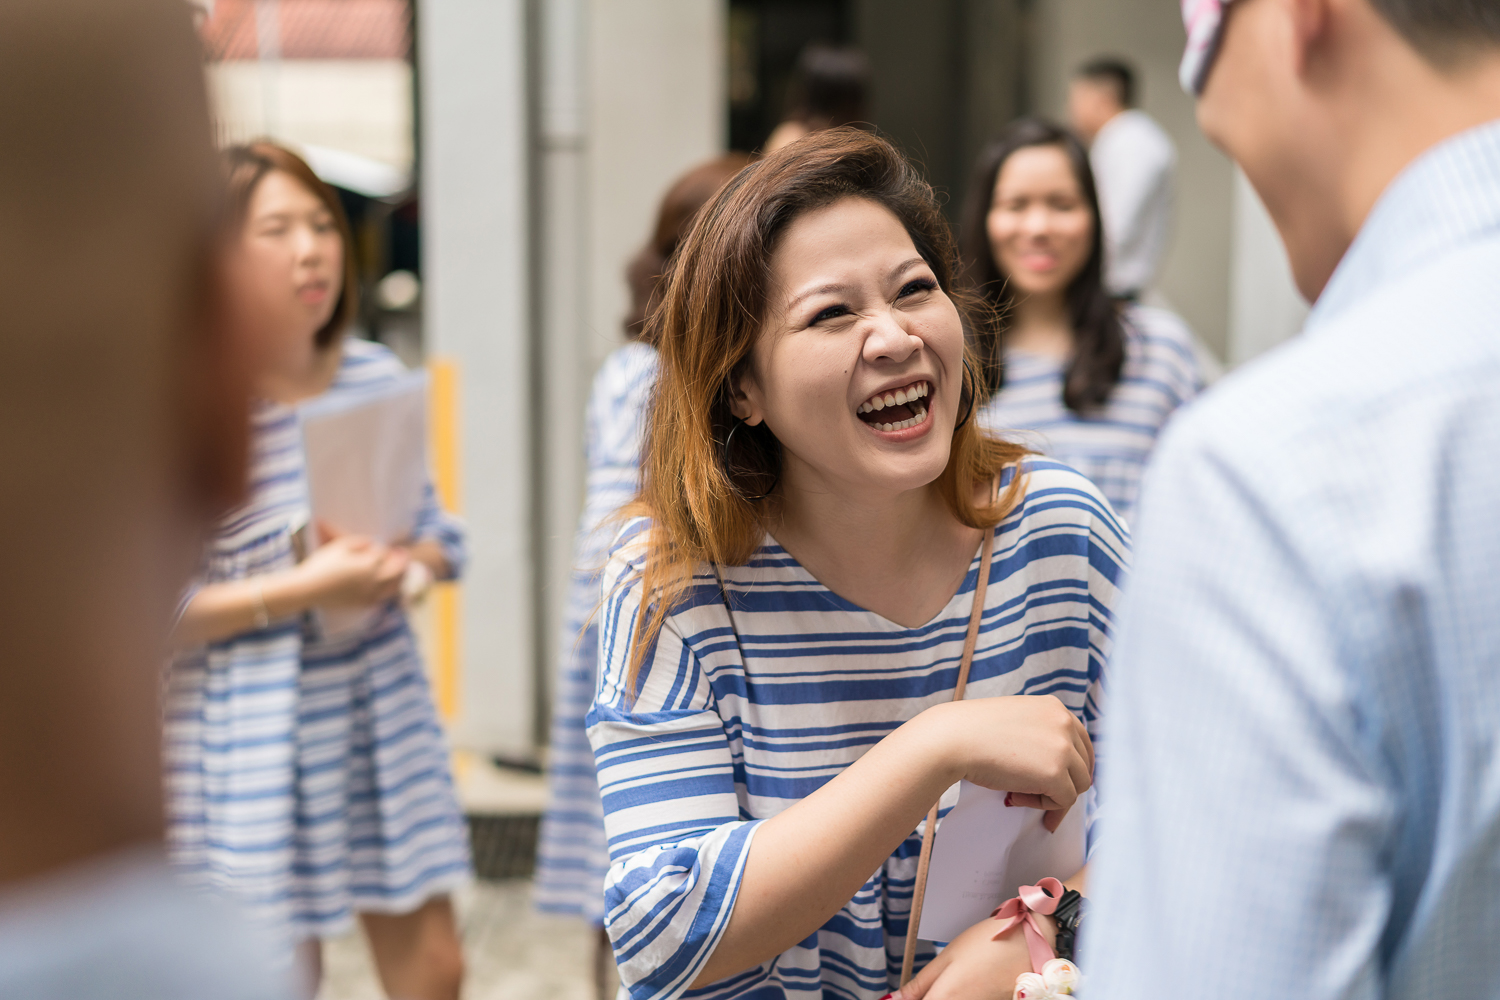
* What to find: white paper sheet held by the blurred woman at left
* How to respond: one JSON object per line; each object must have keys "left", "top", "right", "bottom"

{"left": 299, "top": 372, "right": 428, "bottom": 634}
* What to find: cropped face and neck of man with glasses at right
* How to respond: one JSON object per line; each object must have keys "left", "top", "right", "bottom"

{"left": 1200, "top": 0, "right": 1500, "bottom": 301}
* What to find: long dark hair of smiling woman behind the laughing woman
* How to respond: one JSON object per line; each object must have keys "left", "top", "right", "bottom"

{"left": 959, "top": 118, "right": 1125, "bottom": 412}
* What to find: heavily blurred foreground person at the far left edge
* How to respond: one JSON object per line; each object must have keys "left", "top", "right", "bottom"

{"left": 0, "top": 0, "right": 283, "bottom": 997}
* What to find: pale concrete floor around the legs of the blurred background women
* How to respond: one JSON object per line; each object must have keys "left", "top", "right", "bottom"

{"left": 318, "top": 879, "right": 594, "bottom": 1000}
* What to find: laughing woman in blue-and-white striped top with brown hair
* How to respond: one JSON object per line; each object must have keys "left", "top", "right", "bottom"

{"left": 590, "top": 129, "right": 1128, "bottom": 1000}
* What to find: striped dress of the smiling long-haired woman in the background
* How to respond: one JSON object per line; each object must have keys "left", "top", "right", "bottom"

{"left": 980, "top": 306, "right": 1206, "bottom": 522}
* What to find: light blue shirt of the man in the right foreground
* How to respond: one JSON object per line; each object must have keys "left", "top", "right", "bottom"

{"left": 1082, "top": 123, "right": 1500, "bottom": 1000}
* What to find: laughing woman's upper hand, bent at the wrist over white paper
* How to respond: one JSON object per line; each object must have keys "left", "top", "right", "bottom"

{"left": 923, "top": 694, "right": 1094, "bottom": 831}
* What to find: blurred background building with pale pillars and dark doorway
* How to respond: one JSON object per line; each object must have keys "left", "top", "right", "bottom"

{"left": 200, "top": 0, "right": 1305, "bottom": 765}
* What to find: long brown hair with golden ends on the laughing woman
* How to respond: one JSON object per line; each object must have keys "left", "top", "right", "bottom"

{"left": 624, "top": 127, "right": 1026, "bottom": 691}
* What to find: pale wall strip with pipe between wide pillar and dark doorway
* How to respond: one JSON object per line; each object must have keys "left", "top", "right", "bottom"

{"left": 537, "top": 0, "right": 728, "bottom": 722}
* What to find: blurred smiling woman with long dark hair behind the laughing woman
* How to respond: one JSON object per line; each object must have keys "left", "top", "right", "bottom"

{"left": 959, "top": 118, "right": 1206, "bottom": 520}
